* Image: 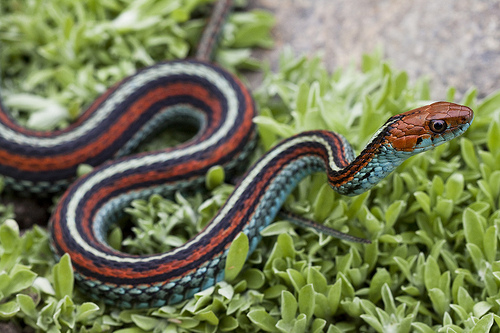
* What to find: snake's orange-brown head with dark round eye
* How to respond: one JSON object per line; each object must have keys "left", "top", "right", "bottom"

{"left": 385, "top": 102, "right": 474, "bottom": 153}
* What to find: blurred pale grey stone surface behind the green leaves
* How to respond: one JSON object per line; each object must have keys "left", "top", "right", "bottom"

{"left": 250, "top": 0, "right": 500, "bottom": 100}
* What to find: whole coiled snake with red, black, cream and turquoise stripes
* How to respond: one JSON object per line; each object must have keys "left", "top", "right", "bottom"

{"left": 0, "top": 0, "right": 474, "bottom": 308}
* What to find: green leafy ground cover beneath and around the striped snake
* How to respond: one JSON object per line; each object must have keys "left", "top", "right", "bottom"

{"left": 0, "top": 0, "right": 500, "bottom": 333}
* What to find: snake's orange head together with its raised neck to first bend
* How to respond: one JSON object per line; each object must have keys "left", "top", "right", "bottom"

{"left": 328, "top": 102, "right": 474, "bottom": 195}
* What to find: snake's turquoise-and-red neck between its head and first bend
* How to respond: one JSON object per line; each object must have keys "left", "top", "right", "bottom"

{"left": 328, "top": 142, "right": 414, "bottom": 196}
